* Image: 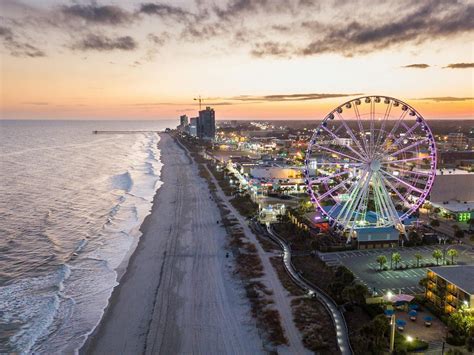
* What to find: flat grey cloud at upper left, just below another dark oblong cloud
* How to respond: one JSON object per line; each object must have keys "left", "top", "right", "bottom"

{"left": 71, "top": 34, "right": 138, "bottom": 51}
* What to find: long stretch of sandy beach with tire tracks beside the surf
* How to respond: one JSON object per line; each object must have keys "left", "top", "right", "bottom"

{"left": 81, "top": 134, "right": 263, "bottom": 354}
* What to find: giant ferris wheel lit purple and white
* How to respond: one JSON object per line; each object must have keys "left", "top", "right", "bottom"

{"left": 305, "top": 96, "right": 436, "bottom": 232}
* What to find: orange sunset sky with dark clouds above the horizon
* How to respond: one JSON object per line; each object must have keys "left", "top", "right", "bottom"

{"left": 0, "top": 0, "right": 474, "bottom": 119}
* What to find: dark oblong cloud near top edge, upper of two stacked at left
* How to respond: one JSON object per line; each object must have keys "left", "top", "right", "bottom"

{"left": 61, "top": 3, "right": 134, "bottom": 26}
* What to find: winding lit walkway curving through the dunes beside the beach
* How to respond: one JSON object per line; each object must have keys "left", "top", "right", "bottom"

{"left": 267, "top": 224, "right": 353, "bottom": 355}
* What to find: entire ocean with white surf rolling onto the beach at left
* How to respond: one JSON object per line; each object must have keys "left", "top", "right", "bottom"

{"left": 0, "top": 120, "right": 176, "bottom": 353}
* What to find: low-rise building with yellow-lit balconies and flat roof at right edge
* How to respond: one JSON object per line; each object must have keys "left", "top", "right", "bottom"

{"left": 426, "top": 265, "right": 474, "bottom": 313}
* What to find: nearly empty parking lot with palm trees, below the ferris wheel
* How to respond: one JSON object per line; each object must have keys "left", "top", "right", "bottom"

{"left": 319, "top": 245, "right": 474, "bottom": 295}
